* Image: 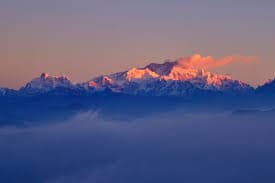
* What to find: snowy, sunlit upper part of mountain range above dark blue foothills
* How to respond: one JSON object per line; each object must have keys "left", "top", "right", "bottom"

{"left": 0, "top": 57, "right": 275, "bottom": 97}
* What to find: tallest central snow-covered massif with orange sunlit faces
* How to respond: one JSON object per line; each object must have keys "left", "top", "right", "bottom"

{"left": 85, "top": 55, "right": 252, "bottom": 95}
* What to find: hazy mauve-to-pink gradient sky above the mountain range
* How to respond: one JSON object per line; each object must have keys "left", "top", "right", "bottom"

{"left": 0, "top": 0, "right": 275, "bottom": 88}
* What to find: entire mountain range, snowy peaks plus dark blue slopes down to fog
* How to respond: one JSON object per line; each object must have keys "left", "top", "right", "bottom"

{"left": 0, "top": 55, "right": 275, "bottom": 126}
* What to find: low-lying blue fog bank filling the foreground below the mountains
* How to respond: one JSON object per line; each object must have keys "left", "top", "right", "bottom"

{"left": 0, "top": 110, "right": 275, "bottom": 183}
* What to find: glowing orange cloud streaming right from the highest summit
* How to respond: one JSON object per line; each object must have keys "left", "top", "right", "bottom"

{"left": 177, "top": 54, "right": 257, "bottom": 69}
